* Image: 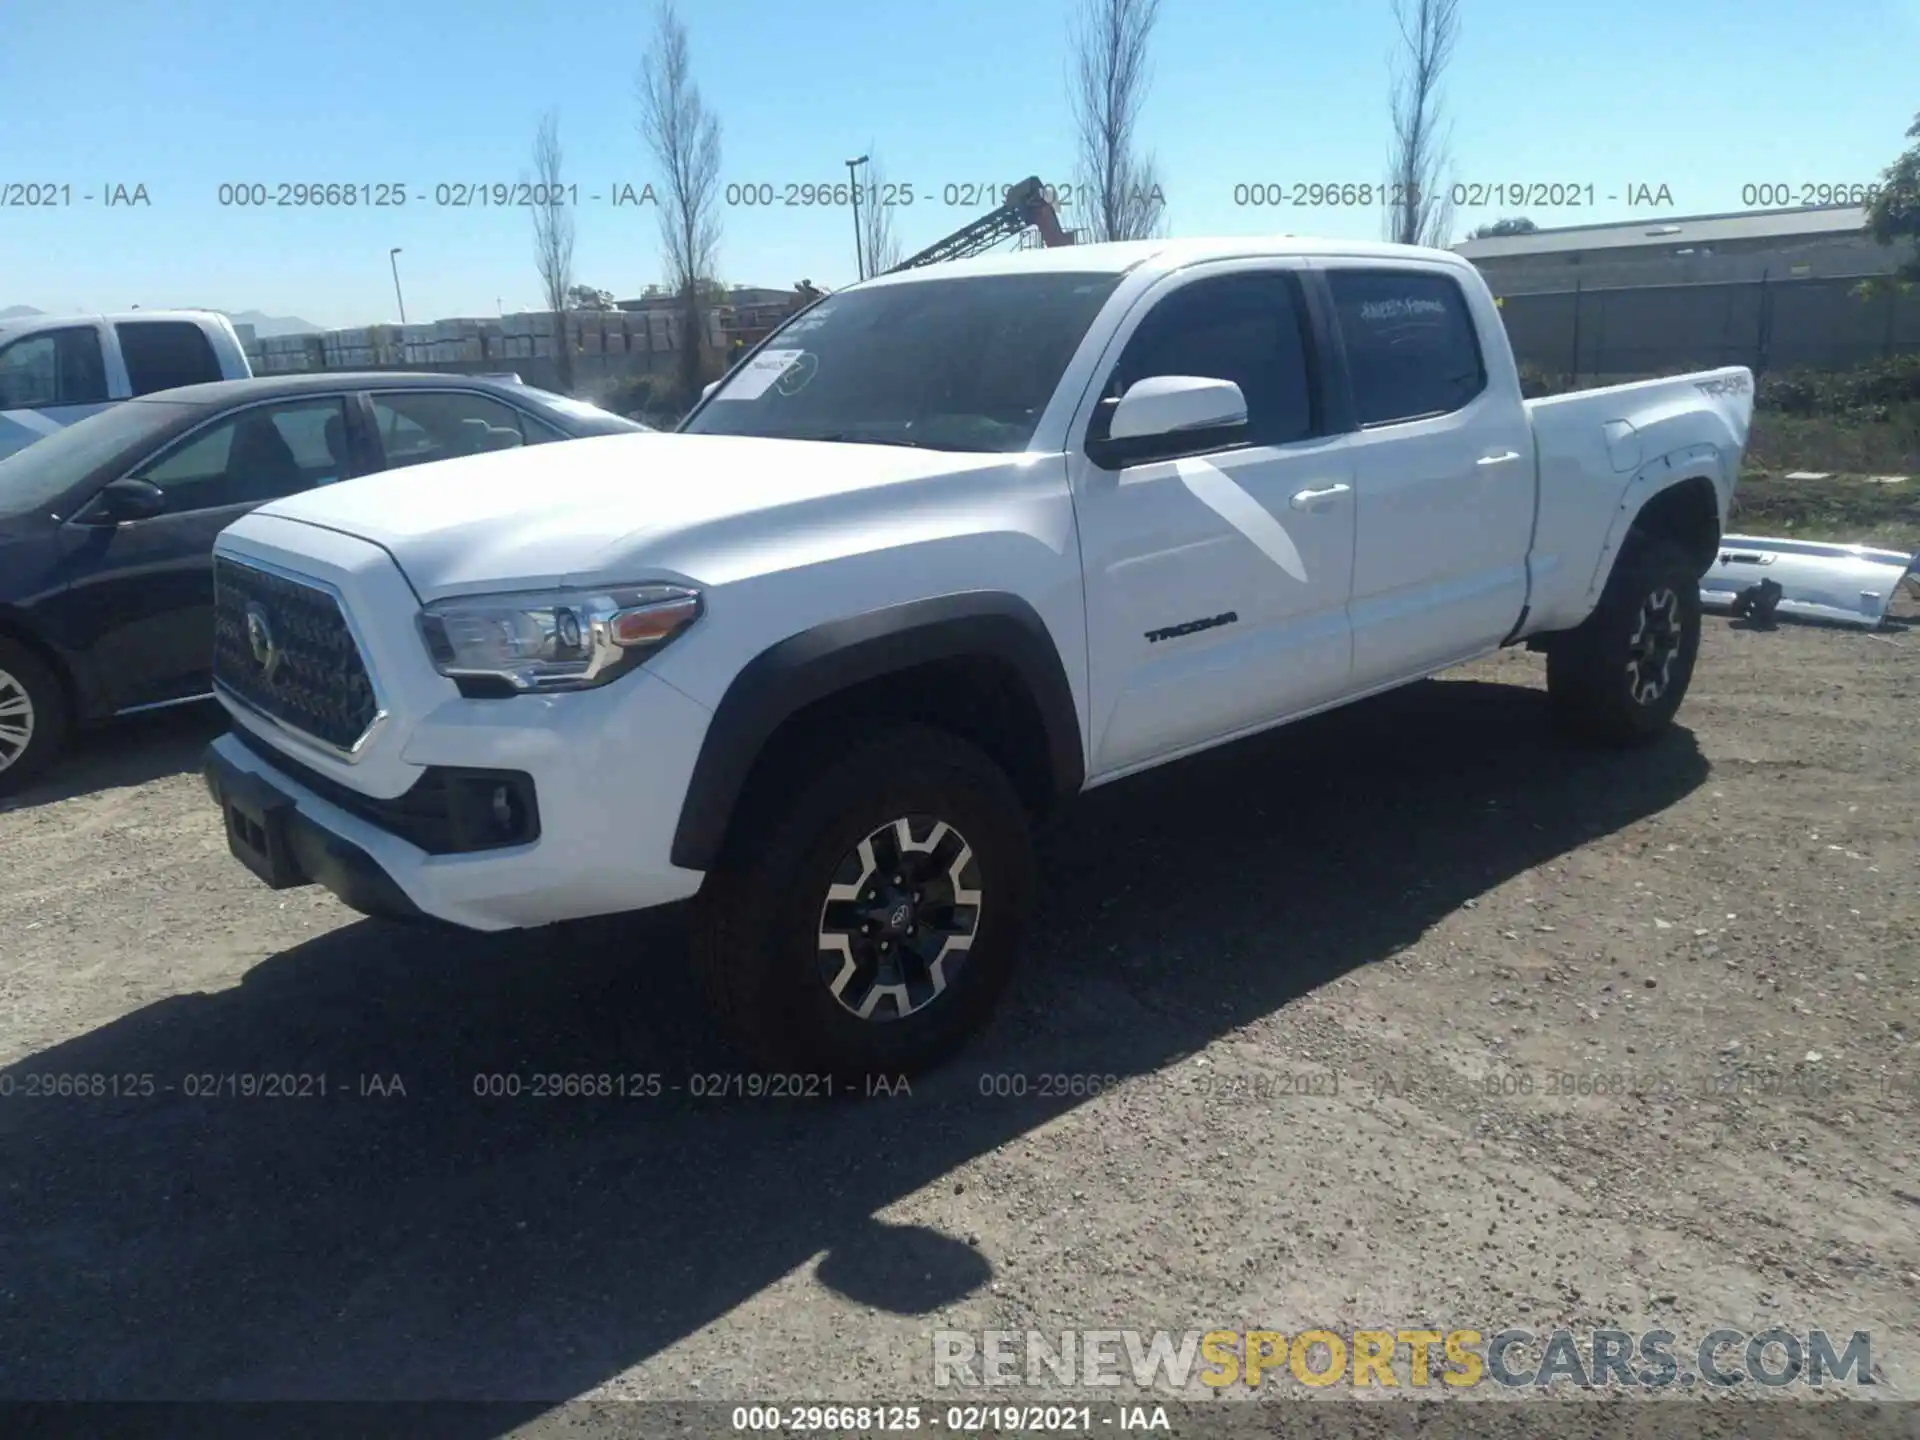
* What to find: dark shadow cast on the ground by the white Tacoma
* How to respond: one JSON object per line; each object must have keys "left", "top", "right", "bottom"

{"left": 0, "top": 680, "right": 1709, "bottom": 1434}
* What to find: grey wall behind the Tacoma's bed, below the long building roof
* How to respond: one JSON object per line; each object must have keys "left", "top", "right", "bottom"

{"left": 1501, "top": 276, "right": 1920, "bottom": 382}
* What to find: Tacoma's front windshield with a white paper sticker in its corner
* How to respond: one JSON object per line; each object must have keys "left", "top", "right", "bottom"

{"left": 682, "top": 273, "right": 1119, "bottom": 451}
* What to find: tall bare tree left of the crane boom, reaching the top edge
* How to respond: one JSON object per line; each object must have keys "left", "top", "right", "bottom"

{"left": 637, "top": 0, "right": 720, "bottom": 403}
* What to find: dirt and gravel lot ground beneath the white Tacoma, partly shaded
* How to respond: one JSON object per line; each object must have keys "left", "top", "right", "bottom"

{"left": 0, "top": 618, "right": 1920, "bottom": 1415}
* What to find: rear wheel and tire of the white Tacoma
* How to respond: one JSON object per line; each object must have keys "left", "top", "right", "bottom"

{"left": 1548, "top": 540, "right": 1699, "bottom": 745}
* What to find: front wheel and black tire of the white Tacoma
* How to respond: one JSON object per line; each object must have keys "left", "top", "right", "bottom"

{"left": 691, "top": 726, "right": 1033, "bottom": 1083}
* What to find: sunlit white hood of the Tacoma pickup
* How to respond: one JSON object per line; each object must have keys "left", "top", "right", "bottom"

{"left": 255, "top": 434, "right": 1018, "bottom": 599}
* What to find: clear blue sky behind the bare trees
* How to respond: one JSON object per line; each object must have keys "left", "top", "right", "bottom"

{"left": 0, "top": 0, "right": 1920, "bottom": 324}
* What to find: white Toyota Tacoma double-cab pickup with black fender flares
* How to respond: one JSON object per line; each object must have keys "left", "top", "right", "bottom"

{"left": 204, "top": 240, "right": 1753, "bottom": 1073}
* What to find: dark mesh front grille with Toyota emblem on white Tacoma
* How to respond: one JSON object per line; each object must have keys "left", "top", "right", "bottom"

{"left": 213, "top": 555, "right": 380, "bottom": 751}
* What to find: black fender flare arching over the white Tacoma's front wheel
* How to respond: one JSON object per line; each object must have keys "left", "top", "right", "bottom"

{"left": 670, "top": 589, "right": 1087, "bottom": 870}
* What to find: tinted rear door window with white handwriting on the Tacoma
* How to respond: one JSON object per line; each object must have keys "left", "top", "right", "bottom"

{"left": 1327, "top": 269, "right": 1486, "bottom": 426}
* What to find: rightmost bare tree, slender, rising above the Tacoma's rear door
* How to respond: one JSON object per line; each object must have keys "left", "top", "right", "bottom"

{"left": 1386, "top": 0, "right": 1459, "bottom": 246}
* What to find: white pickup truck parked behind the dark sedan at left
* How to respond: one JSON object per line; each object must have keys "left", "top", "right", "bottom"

{"left": 0, "top": 309, "right": 253, "bottom": 459}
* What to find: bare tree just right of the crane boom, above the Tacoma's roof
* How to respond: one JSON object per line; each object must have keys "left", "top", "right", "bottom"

{"left": 1068, "top": 0, "right": 1167, "bottom": 240}
